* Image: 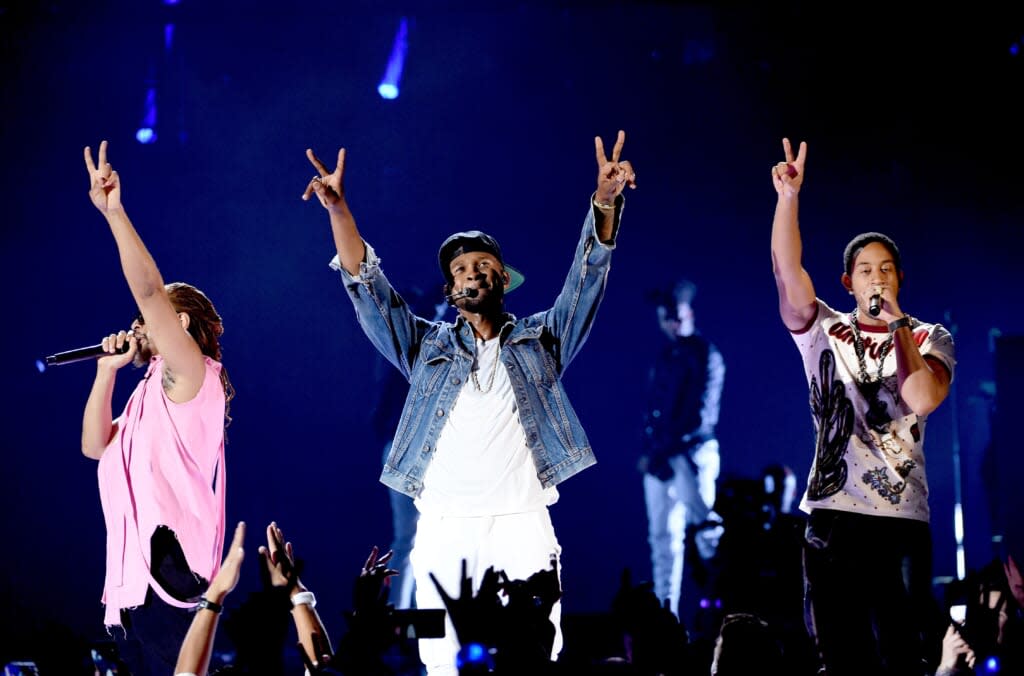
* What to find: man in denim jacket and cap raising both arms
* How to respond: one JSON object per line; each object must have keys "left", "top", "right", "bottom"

{"left": 303, "top": 131, "right": 636, "bottom": 676}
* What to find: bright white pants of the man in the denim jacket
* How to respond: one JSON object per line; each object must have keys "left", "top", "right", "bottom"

{"left": 411, "top": 509, "right": 562, "bottom": 676}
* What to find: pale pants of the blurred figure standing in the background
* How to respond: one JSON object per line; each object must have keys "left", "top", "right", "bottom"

{"left": 643, "top": 439, "right": 721, "bottom": 616}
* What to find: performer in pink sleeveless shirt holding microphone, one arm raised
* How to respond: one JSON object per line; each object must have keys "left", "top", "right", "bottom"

{"left": 82, "top": 141, "right": 233, "bottom": 676}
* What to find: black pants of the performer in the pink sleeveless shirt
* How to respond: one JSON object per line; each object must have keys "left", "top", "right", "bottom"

{"left": 113, "top": 526, "right": 208, "bottom": 676}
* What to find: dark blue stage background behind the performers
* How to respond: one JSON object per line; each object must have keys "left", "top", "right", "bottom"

{"left": 0, "top": 0, "right": 1024, "bottom": 657}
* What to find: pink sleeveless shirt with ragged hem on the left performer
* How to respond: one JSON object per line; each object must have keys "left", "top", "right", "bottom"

{"left": 97, "top": 356, "right": 225, "bottom": 626}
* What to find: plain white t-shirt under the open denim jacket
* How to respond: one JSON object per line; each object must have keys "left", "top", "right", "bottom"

{"left": 416, "top": 338, "right": 558, "bottom": 516}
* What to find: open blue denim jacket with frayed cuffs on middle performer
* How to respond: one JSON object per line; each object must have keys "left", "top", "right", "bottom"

{"left": 331, "top": 198, "right": 623, "bottom": 497}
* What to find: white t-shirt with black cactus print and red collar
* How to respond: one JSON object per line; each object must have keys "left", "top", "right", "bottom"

{"left": 793, "top": 299, "right": 955, "bottom": 521}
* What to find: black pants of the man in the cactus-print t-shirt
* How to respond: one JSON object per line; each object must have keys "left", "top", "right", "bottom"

{"left": 804, "top": 509, "right": 938, "bottom": 676}
